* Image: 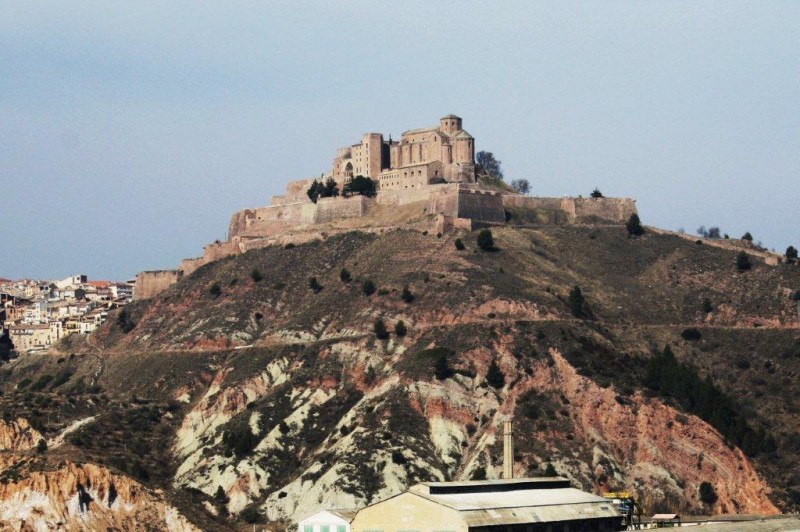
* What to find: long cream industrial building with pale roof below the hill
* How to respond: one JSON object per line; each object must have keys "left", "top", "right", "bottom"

{"left": 352, "top": 477, "right": 624, "bottom": 532}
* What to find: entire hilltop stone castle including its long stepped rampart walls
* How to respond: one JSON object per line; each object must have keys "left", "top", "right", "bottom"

{"left": 134, "top": 114, "right": 636, "bottom": 299}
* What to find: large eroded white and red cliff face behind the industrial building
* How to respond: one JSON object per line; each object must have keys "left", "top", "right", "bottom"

{"left": 167, "top": 337, "right": 778, "bottom": 520}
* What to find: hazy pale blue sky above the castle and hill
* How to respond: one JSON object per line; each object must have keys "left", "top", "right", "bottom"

{"left": 0, "top": 0, "right": 800, "bottom": 280}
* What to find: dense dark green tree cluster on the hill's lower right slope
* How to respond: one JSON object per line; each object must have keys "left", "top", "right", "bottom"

{"left": 643, "top": 345, "right": 777, "bottom": 456}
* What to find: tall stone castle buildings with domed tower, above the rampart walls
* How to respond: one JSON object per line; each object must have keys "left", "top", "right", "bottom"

{"left": 324, "top": 115, "right": 475, "bottom": 190}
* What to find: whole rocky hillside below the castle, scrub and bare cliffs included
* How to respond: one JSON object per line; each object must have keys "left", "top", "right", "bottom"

{"left": 0, "top": 222, "right": 800, "bottom": 529}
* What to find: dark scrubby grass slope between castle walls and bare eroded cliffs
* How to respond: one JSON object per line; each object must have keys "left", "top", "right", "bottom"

{"left": 0, "top": 226, "right": 800, "bottom": 524}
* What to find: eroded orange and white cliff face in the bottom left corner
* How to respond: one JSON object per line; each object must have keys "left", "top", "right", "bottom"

{"left": 0, "top": 457, "right": 199, "bottom": 532}
